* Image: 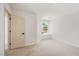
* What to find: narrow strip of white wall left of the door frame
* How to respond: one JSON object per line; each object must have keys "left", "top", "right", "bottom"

{"left": 0, "top": 4, "right": 4, "bottom": 56}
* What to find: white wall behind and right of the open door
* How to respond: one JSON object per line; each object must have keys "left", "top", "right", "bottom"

{"left": 13, "top": 10, "right": 37, "bottom": 46}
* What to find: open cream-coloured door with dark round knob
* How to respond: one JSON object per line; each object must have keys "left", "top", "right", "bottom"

{"left": 10, "top": 16, "right": 25, "bottom": 49}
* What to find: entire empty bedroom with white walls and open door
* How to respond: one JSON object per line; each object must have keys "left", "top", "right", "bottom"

{"left": 0, "top": 3, "right": 79, "bottom": 56}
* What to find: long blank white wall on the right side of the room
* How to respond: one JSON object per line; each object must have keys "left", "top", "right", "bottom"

{"left": 52, "top": 11, "right": 79, "bottom": 48}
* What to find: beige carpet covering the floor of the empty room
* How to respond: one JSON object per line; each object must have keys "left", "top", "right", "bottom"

{"left": 5, "top": 40, "right": 79, "bottom": 56}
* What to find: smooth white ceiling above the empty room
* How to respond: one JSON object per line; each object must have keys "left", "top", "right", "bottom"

{"left": 9, "top": 3, "right": 79, "bottom": 14}
